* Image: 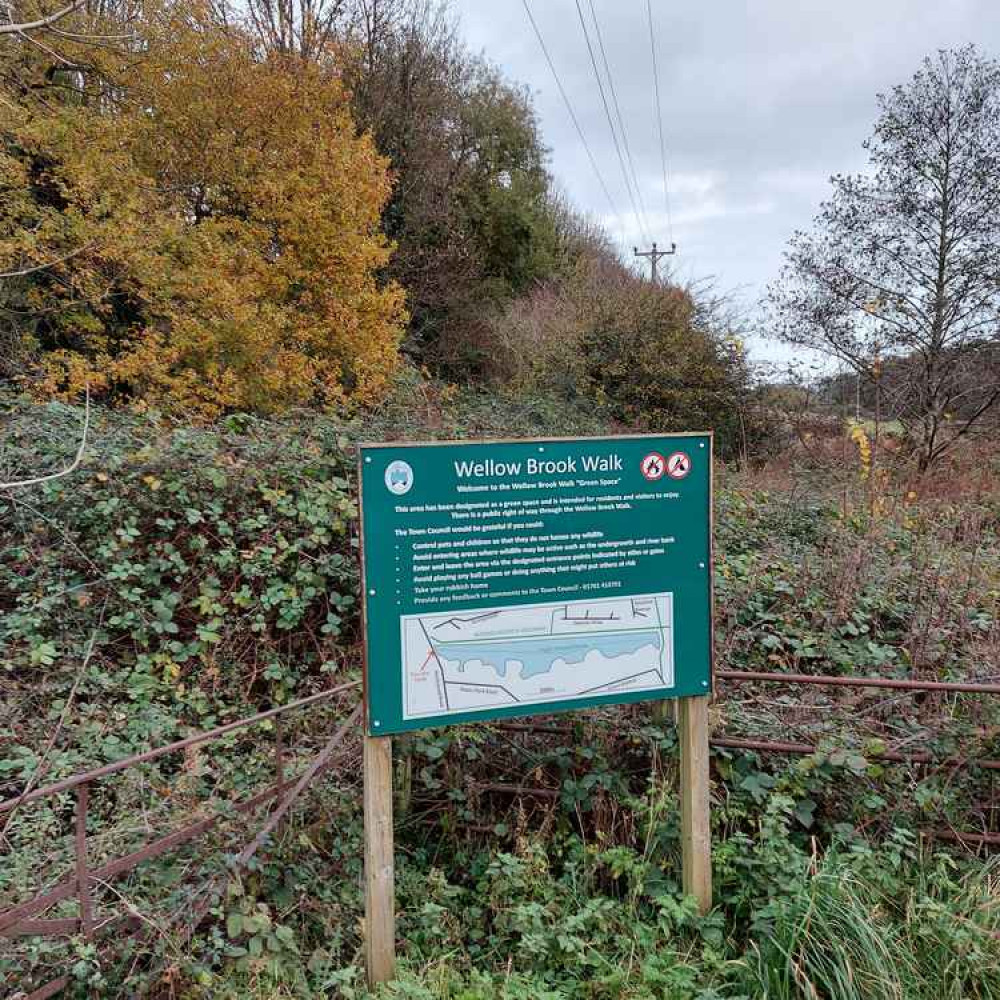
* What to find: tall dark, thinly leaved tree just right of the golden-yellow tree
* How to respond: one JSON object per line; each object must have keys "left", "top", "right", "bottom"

{"left": 205, "top": 0, "right": 584, "bottom": 379}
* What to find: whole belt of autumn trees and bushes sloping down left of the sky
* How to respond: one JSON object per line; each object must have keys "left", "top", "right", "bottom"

{"left": 0, "top": 0, "right": 749, "bottom": 450}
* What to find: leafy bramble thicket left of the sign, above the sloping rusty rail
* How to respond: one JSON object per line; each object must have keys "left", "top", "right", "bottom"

{"left": 0, "top": 401, "right": 357, "bottom": 781}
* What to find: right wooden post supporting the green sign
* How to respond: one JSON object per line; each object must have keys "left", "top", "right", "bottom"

{"left": 678, "top": 695, "right": 712, "bottom": 913}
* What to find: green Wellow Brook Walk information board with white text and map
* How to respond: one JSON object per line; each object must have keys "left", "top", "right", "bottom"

{"left": 360, "top": 434, "right": 712, "bottom": 736}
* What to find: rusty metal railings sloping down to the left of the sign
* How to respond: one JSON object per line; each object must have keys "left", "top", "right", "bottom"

{"left": 0, "top": 681, "right": 361, "bottom": 1000}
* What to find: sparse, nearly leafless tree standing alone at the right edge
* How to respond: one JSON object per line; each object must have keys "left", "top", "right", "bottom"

{"left": 769, "top": 46, "right": 1000, "bottom": 471}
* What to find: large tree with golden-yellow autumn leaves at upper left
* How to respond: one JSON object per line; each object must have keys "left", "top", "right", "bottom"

{"left": 0, "top": 6, "right": 405, "bottom": 416}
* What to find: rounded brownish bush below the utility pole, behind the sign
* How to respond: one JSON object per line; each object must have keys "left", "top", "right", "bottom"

{"left": 493, "top": 255, "right": 757, "bottom": 458}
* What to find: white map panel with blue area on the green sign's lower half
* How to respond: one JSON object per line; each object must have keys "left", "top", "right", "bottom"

{"left": 400, "top": 593, "right": 674, "bottom": 719}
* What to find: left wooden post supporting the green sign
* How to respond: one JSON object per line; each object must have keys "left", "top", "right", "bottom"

{"left": 364, "top": 736, "right": 396, "bottom": 989}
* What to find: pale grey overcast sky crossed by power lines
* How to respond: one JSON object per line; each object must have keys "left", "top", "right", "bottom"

{"left": 453, "top": 0, "right": 1000, "bottom": 358}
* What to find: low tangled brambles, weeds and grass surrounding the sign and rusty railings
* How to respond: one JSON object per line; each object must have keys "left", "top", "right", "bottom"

{"left": 0, "top": 394, "right": 1000, "bottom": 1000}
